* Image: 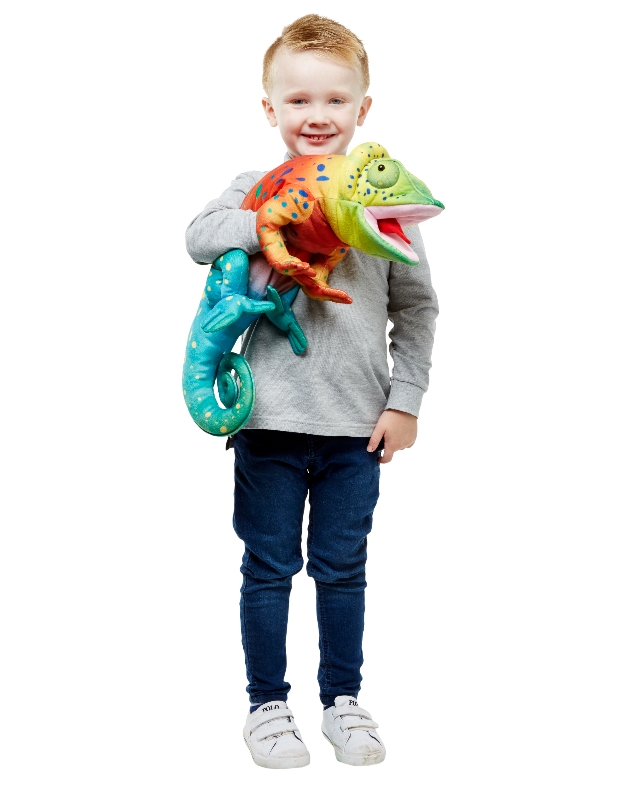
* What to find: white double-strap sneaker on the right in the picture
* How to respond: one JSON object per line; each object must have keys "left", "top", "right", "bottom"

{"left": 322, "top": 695, "right": 385, "bottom": 766}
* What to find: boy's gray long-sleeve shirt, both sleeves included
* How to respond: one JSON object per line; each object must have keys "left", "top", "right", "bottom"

{"left": 186, "top": 172, "right": 438, "bottom": 437}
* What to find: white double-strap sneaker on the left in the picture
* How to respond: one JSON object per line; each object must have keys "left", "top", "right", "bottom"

{"left": 243, "top": 700, "right": 311, "bottom": 769}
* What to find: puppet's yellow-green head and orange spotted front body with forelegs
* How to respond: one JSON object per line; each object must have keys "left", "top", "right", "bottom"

{"left": 241, "top": 142, "right": 444, "bottom": 304}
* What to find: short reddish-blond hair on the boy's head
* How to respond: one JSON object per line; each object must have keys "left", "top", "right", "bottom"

{"left": 263, "top": 14, "right": 370, "bottom": 95}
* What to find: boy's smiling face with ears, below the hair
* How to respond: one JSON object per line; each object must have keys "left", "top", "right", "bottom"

{"left": 263, "top": 48, "right": 372, "bottom": 156}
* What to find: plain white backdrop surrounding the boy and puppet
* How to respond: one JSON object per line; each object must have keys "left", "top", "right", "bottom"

{"left": 0, "top": 0, "right": 630, "bottom": 788}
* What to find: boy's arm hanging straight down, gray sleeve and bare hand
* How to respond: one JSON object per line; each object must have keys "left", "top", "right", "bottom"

{"left": 368, "top": 226, "right": 438, "bottom": 463}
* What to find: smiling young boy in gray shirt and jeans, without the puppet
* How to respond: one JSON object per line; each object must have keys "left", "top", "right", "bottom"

{"left": 186, "top": 14, "right": 438, "bottom": 769}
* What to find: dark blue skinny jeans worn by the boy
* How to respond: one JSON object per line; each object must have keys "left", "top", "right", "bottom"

{"left": 233, "top": 429, "right": 380, "bottom": 705}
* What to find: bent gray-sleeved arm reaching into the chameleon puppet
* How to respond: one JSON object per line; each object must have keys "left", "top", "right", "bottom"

{"left": 186, "top": 172, "right": 263, "bottom": 264}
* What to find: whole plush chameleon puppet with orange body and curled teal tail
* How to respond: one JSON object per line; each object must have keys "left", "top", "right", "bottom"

{"left": 183, "top": 142, "right": 444, "bottom": 435}
